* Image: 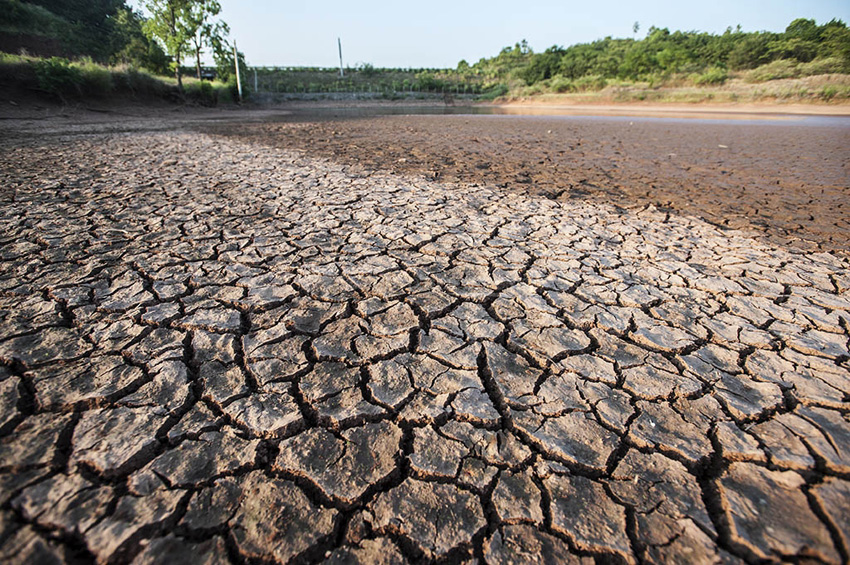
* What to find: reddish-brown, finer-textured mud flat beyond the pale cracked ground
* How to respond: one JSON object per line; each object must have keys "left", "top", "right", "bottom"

{"left": 202, "top": 110, "right": 850, "bottom": 252}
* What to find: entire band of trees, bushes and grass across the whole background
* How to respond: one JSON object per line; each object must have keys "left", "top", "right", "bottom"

{"left": 0, "top": 5, "right": 850, "bottom": 104}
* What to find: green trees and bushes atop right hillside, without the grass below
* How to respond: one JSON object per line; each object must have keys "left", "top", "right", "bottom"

{"left": 457, "top": 18, "right": 850, "bottom": 86}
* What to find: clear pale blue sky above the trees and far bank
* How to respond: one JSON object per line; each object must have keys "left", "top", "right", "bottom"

{"left": 130, "top": 0, "right": 850, "bottom": 68}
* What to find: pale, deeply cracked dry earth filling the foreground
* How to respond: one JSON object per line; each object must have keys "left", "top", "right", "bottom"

{"left": 0, "top": 115, "right": 850, "bottom": 564}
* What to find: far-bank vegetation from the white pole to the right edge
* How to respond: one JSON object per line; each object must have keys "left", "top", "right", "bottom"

{"left": 255, "top": 19, "right": 850, "bottom": 101}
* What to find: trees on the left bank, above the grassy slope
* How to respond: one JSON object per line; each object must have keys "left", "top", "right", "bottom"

{"left": 0, "top": 0, "right": 244, "bottom": 89}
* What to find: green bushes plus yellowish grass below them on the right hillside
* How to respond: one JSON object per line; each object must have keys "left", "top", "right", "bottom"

{"left": 464, "top": 19, "right": 850, "bottom": 95}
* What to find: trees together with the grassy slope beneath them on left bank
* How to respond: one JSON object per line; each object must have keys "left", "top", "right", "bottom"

{"left": 0, "top": 0, "right": 240, "bottom": 104}
